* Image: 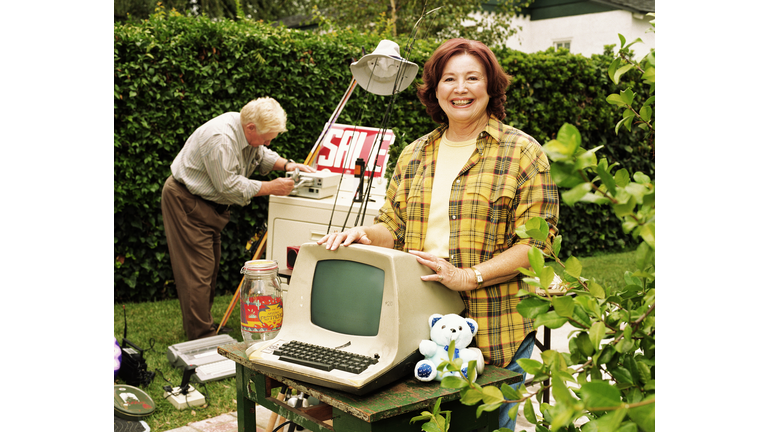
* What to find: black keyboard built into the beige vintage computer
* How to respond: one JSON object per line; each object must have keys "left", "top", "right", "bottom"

{"left": 273, "top": 341, "right": 379, "bottom": 374}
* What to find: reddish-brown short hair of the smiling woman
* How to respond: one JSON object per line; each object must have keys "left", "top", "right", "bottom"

{"left": 416, "top": 38, "right": 509, "bottom": 123}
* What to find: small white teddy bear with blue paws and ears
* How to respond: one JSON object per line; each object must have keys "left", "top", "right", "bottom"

{"left": 413, "top": 314, "right": 485, "bottom": 381}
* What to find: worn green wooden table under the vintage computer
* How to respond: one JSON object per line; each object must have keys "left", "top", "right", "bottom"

{"left": 218, "top": 342, "right": 522, "bottom": 432}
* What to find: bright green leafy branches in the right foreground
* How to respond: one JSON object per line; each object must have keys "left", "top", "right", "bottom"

{"left": 412, "top": 13, "right": 656, "bottom": 432}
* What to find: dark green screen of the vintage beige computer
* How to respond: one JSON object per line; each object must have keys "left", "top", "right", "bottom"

{"left": 310, "top": 259, "right": 384, "bottom": 336}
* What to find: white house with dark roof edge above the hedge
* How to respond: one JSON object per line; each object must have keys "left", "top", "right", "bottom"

{"left": 483, "top": 0, "right": 656, "bottom": 59}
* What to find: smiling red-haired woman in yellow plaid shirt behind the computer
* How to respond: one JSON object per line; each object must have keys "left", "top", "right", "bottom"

{"left": 318, "top": 39, "right": 559, "bottom": 430}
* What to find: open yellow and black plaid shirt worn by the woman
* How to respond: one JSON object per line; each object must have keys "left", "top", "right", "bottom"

{"left": 376, "top": 117, "right": 560, "bottom": 367}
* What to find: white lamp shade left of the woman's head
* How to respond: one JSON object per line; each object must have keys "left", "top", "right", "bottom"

{"left": 349, "top": 39, "right": 419, "bottom": 96}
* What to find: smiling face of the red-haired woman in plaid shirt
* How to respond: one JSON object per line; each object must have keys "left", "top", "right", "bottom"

{"left": 437, "top": 54, "right": 489, "bottom": 125}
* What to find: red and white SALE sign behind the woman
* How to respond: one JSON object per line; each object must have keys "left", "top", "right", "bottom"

{"left": 317, "top": 123, "right": 395, "bottom": 177}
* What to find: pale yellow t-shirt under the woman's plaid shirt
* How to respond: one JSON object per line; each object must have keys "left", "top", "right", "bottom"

{"left": 424, "top": 134, "right": 476, "bottom": 258}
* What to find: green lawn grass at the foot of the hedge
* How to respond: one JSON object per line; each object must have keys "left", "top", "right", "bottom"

{"left": 114, "top": 248, "right": 634, "bottom": 431}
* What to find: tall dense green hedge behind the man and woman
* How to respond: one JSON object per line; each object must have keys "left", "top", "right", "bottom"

{"left": 114, "top": 13, "right": 653, "bottom": 301}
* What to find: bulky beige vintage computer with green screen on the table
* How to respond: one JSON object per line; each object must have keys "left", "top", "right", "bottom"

{"left": 246, "top": 243, "right": 464, "bottom": 395}
